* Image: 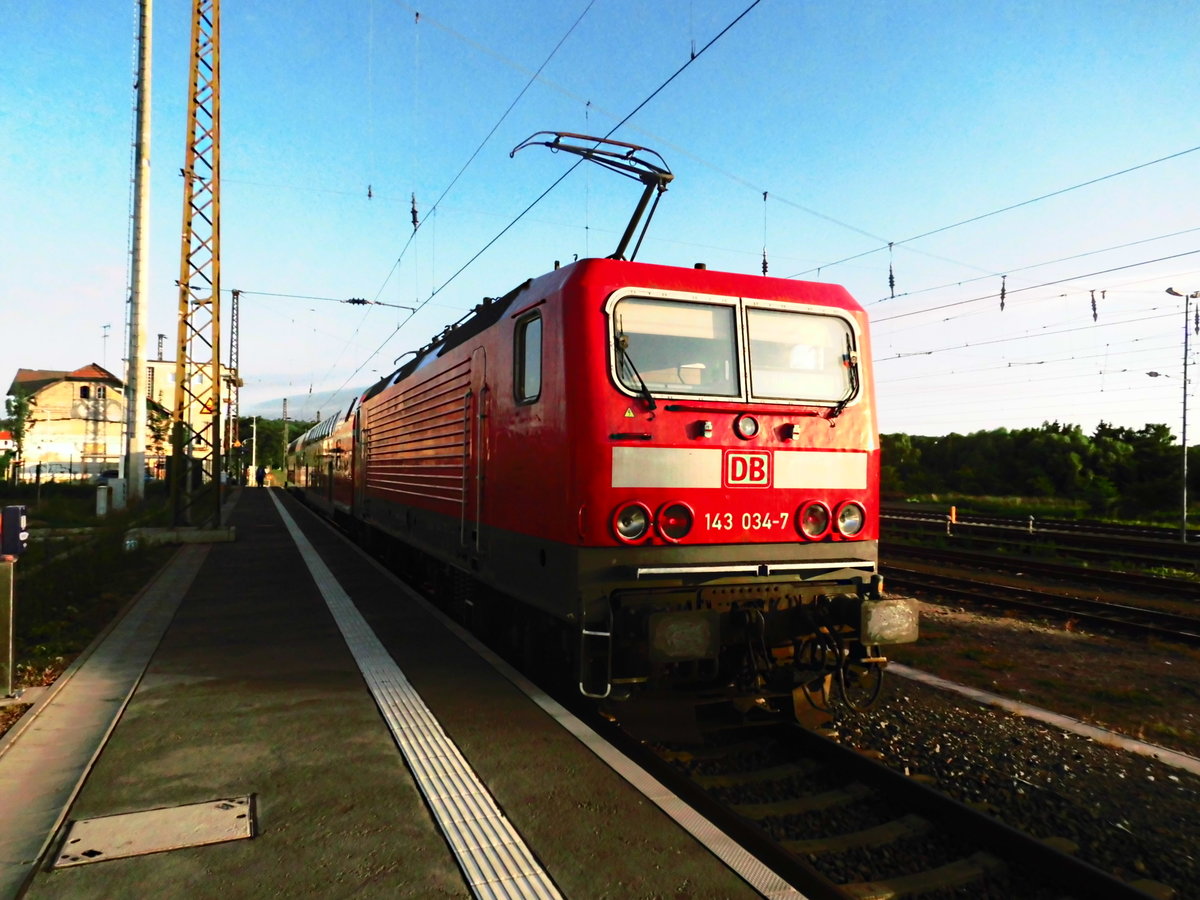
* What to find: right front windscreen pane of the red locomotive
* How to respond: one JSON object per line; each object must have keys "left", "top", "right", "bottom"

{"left": 746, "top": 308, "right": 854, "bottom": 403}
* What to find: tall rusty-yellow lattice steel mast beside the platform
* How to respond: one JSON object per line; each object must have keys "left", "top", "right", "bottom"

{"left": 170, "top": 0, "right": 221, "bottom": 526}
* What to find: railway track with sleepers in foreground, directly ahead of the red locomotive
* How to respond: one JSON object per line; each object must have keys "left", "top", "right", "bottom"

{"left": 609, "top": 726, "right": 1163, "bottom": 900}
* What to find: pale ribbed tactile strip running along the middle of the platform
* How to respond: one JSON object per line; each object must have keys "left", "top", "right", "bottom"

{"left": 271, "top": 491, "right": 562, "bottom": 900}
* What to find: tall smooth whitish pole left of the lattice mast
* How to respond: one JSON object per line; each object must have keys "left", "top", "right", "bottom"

{"left": 124, "top": 0, "right": 154, "bottom": 504}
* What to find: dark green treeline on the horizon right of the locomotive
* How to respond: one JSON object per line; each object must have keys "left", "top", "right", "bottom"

{"left": 880, "top": 421, "right": 1200, "bottom": 516}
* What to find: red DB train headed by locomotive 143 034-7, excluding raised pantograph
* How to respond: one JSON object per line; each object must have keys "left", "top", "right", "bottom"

{"left": 288, "top": 135, "right": 917, "bottom": 734}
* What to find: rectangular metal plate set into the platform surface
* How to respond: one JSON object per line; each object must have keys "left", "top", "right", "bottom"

{"left": 52, "top": 797, "right": 254, "bottom": 869}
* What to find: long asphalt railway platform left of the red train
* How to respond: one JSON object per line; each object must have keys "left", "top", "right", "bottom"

{"left": 0, "top": 488, "right": 799, "bottom": 900}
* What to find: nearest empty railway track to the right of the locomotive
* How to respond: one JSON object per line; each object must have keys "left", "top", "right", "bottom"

{"left": 881, "top": 565, "right": 1200, "bottom": 643}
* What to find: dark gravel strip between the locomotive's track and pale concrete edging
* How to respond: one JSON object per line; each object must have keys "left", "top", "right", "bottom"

{"left": 833, "top": 677, "right": 1200, "bottom": 899}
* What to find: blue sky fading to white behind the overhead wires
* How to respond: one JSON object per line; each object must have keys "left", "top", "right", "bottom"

{"left": 0, "top": 0, "right": 1200, "bottom": 438}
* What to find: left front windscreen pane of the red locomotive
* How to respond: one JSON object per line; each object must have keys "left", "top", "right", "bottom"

{"left": 613, "top": 298, "right": 740, "bottom": 397}
